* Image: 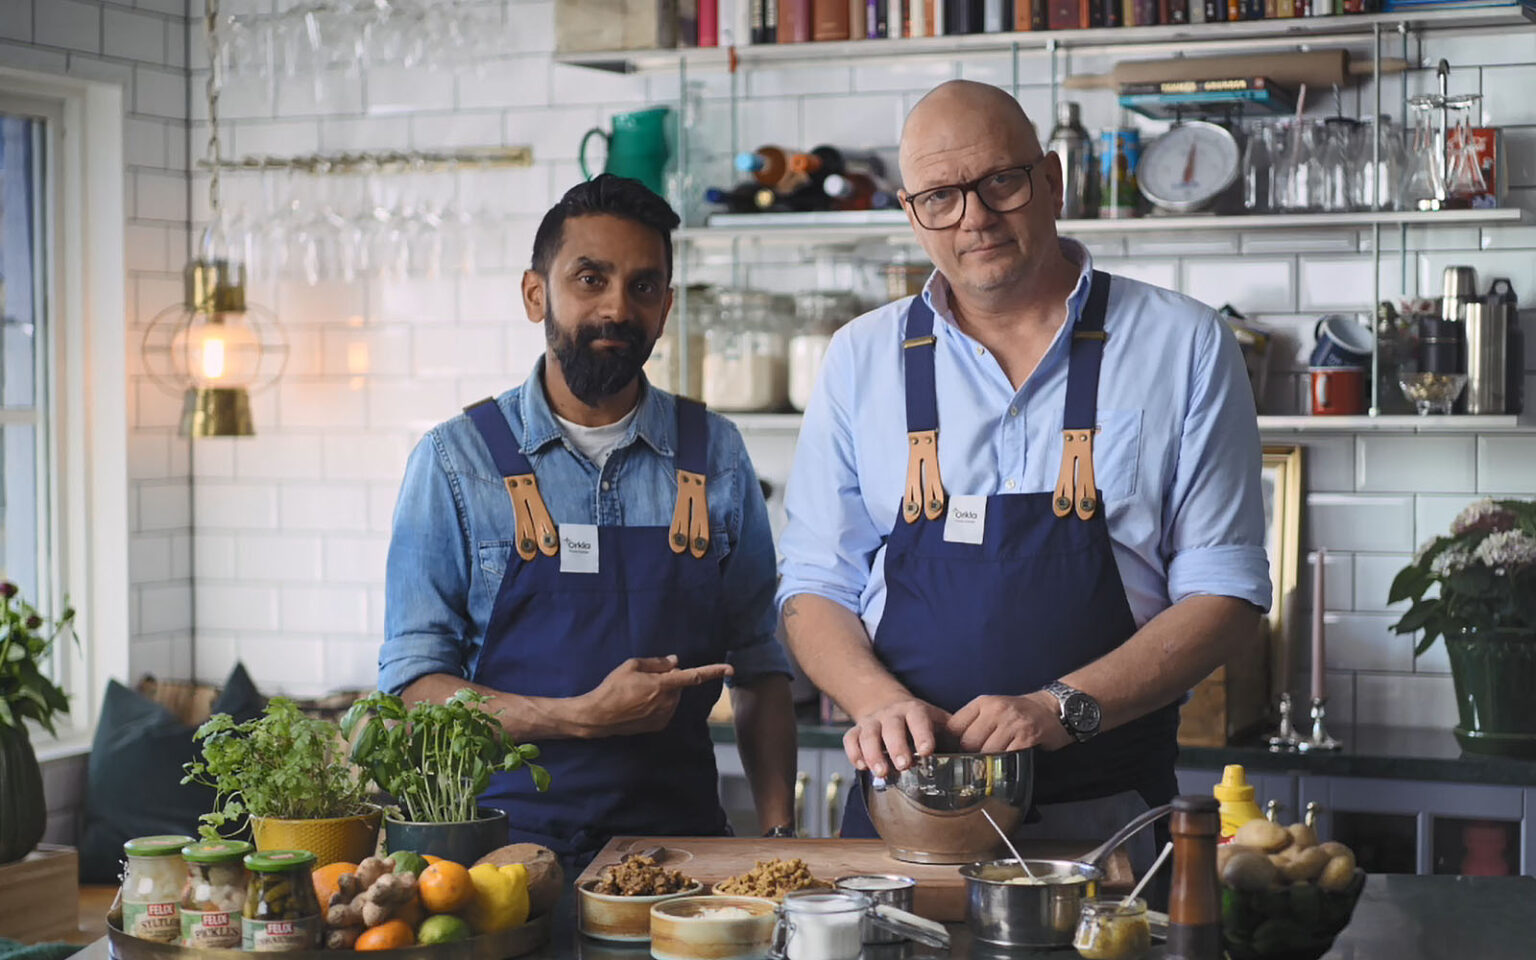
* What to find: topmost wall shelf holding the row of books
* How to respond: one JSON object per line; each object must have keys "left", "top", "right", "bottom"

{"left": 554, "top": 3, "right": 1536, "bottom": 74}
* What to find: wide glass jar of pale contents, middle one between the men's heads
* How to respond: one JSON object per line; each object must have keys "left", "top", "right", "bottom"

{"left": 703, "top": 290, "right": 790, "bottom": 413}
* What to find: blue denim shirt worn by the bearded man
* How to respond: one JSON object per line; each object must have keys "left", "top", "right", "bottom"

{"left": 378, "top": 359, "right": 790, "bottom": 693}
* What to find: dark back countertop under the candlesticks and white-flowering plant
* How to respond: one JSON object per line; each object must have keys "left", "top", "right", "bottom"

{"left": 711, "top": 723, "right": 1536, "bottom": 786}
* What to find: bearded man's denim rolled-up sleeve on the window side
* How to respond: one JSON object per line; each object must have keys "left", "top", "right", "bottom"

{"left": 378, "top": 432, "right": 472, "bottom": 694}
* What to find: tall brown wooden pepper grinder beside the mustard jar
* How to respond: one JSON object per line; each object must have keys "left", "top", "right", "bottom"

{"left": 1163, "top": 796, "right": 1221, "bottom": 960}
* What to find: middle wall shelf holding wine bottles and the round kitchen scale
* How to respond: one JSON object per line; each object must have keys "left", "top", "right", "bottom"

{"left": 685, "top": 207, "right": 1536, "bottom": 246}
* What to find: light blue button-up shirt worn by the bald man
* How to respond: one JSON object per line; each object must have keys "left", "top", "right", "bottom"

{"left": 779, "top": 240, "right": 1270, "bottom": 642}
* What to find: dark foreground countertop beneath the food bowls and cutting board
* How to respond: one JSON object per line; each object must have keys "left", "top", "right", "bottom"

{"left": 75, "top": 876, "right": 1536, "bottom": 960}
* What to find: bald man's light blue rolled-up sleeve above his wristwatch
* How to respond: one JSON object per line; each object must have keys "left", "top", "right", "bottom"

{"left": 1163, "top": 313, "right": 1270, "bottom": 610}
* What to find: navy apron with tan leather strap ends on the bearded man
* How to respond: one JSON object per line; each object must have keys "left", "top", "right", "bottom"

{"left": 465, "top": 384, "right": 728, "bottom": 862}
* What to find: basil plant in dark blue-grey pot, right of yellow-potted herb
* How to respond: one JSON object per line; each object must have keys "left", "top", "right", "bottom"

{"left": 341, "top": 688, "right": 550, "bottom": 865}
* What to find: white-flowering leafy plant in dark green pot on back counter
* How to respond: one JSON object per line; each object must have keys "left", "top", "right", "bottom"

{"left": 1390, "top": 499, "right": 1536, "bottom": 757}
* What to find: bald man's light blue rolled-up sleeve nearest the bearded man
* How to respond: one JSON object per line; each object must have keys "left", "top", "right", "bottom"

{"left": 779, "top": 329, "right": 883, "bottom": 614}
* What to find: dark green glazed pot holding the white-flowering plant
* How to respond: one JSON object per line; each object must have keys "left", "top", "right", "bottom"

{"left": 1445, "top": 634, "right": 1536, "bottom": 759}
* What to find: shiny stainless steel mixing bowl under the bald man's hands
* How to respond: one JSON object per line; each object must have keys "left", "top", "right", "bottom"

{"left": 859, "top": 750, "right": 1035, "bottom": 863}
